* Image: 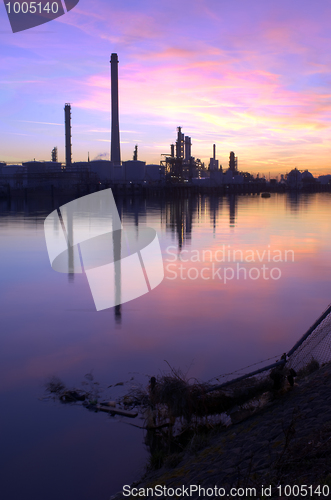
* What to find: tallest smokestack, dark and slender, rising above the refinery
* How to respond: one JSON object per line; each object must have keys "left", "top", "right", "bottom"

{"left": 110, "top": 54, "right": 121, "bottom": 165}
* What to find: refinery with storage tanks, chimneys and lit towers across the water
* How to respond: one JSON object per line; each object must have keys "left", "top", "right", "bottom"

{"left": 0, "top": 53, "right": 248, "bottom": 188}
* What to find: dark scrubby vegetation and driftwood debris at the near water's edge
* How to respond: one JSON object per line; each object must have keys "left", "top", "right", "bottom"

{"left": 46, "top": 361, "right": 319, "bottom": 469}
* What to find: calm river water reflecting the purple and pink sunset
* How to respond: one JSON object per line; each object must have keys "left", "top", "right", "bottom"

{"left": 0, "top": 193, "right": 331, "bottom": 500}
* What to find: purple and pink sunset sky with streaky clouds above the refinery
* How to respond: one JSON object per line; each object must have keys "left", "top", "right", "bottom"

{"left": 0, "top": 0, "right": 331, "bottom": 176}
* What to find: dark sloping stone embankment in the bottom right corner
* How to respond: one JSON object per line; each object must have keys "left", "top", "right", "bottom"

{"left": 112, "top": 364, "right": 331, "bottom": 500}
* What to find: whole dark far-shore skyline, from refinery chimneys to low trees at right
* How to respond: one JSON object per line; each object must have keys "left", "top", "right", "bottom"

{"left": 0, "top": 54, "right": 331, "bottom": 194}
